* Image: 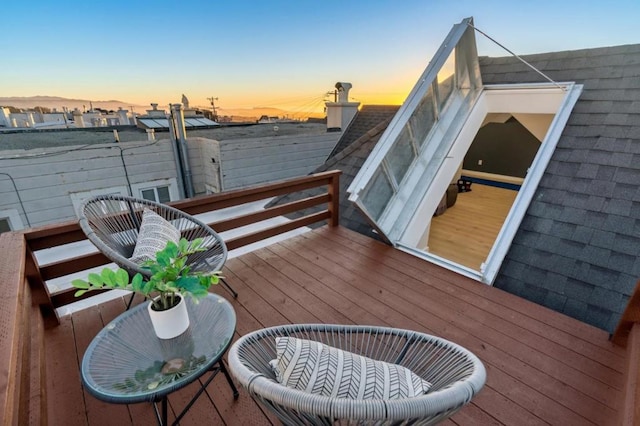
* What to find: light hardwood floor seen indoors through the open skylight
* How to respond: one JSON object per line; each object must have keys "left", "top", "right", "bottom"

{"left": 428, "top": 183, "right": 518, "bottom": 270}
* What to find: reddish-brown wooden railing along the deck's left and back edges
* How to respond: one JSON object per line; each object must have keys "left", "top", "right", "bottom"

{"left": 0, "top": 171, "right": 340, "bottom": 425}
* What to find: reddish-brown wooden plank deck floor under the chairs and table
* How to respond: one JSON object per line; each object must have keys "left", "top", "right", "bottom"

{"left": 45, "top": 227, "right": 625, "bottom": 426}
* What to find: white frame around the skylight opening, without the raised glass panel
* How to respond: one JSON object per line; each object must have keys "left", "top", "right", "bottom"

{"left": 394, "top": 83, "right": 583, "bottom": 285}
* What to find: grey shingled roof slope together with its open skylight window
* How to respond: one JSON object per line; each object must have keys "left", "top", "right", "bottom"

{"left": 272, "top": 20, "right": 640, "bottom": 331}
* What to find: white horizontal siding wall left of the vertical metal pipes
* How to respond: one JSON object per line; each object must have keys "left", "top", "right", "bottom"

{"left": 0, "top": 140, "right": 176, "bottom": 227}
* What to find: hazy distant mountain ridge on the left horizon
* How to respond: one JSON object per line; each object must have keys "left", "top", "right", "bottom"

{"left": 0, "top": 96, "right": 151, "bottom": 113}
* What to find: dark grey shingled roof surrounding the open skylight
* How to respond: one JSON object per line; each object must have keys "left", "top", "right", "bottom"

{"left": 272, "top": 44, "right": 640, "bottom": 331}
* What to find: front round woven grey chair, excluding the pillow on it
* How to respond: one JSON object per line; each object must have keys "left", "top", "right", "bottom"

{"left": 229, "top": 324, "right": 486, "bottom": 425}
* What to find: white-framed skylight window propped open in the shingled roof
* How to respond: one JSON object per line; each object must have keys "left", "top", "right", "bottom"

{"left": 348, "top": 18, "right": 582, "bottom": 284}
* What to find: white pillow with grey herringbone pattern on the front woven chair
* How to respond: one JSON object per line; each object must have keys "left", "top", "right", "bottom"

{"left": 271, "top": 337, "right": 431, "bottom": 399}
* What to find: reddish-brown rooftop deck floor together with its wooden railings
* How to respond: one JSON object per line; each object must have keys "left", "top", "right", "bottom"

{"left": 0, "top": 173, "right": 630, "bottom": 425}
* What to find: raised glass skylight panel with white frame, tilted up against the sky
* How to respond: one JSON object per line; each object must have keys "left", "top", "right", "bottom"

{"left": 348, "top": 18, "right": 482, "bottom": 242}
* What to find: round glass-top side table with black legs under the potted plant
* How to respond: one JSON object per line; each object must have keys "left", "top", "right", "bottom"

{"left": 81, "top": 293, "right": 238, "bottom": 425}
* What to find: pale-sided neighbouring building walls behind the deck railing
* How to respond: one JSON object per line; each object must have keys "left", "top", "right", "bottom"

{"left": 0, "top": 120, "right": 340, "bottom": 232}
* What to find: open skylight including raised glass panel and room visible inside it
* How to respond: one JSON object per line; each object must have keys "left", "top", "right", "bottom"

{"left": 348, "top": 18, "right": 581, "bottom": 284}
